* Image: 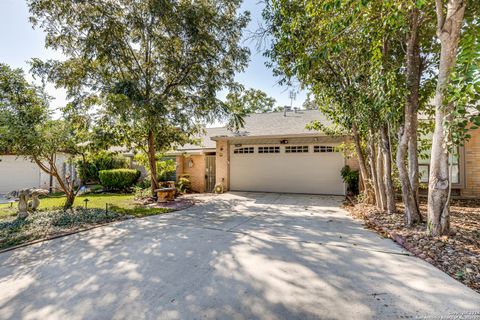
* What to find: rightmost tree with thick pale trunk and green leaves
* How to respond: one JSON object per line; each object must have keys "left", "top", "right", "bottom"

{"left": 427, "top": 0, "right": 480, "bottom": 236}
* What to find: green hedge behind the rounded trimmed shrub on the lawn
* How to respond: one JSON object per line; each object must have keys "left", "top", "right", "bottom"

{"left": 76, "top": 151, "right": 128, "bottom": 183}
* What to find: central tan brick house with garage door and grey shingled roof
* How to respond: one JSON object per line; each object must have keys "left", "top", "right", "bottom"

{"left": 175, "top": 110, "right": 358, "bottom": 195}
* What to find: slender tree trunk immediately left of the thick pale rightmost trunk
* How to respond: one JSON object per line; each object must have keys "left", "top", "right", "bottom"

{"left": 396, "top": 8, "right": 421, "bottom": 226}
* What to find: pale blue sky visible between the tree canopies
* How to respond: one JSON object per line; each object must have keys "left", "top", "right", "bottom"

{"left": 0, "top": 0, "right": 306, "bottom": 109}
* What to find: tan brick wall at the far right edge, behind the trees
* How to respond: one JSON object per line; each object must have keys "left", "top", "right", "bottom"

{"left": 461, "top": 129, "right": 480, "bottom": 198}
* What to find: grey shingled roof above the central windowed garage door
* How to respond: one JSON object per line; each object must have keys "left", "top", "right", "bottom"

{"left": 177, "top": 110, "right": 332, "bottom": 151}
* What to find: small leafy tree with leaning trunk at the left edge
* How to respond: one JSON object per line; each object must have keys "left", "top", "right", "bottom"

{"left": 0, "top": 64, "right": 86, "bottom": 209}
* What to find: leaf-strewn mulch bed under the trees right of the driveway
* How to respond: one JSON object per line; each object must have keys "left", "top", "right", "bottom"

{"left": 346, "top": 200, "right": 480, "bottom": 293}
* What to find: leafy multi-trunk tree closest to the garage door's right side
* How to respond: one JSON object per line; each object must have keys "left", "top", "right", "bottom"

{"left": 264, "top": 0, "right": 401, "bottom": 211}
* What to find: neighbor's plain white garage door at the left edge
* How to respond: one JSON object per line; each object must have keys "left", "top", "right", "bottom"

{"left": 0, "top": 156, "right": 41, "bottom": 193}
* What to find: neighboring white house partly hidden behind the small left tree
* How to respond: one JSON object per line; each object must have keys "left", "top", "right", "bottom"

{"left": 0, "top": 153, "right": 75, "bottom": 194}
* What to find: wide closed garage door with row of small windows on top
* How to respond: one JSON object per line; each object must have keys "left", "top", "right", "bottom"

{"left": 230, "top": 145, "right": 345, "bottom": 195}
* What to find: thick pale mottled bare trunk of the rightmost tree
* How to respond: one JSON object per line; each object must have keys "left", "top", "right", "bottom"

{"left": 427, "top": 0, "right": 466, "bottom": 236}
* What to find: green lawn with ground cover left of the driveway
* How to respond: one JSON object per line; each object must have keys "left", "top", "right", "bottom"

{"left": 0, "top": 194, "right": 171, "bottom": 249}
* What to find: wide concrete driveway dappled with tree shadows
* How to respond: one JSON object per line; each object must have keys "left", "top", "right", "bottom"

{"left": 0, "top": 193, "right": 480, "bottom": 319}
